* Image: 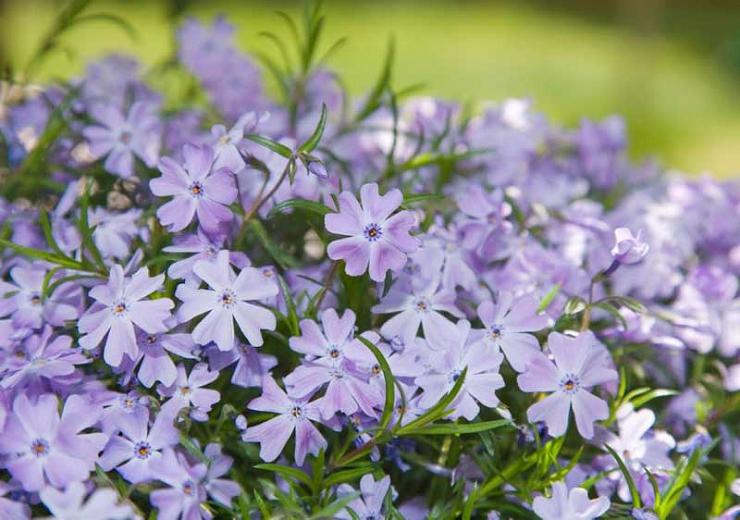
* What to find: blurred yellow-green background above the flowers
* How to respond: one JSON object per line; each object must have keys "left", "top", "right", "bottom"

{"left": 0, "top": 0, "right": 740, "bottom": 177}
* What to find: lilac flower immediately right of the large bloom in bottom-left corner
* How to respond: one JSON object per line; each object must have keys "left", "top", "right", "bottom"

{"left": 100, "top": 412, "right": 180, "bottom": 484}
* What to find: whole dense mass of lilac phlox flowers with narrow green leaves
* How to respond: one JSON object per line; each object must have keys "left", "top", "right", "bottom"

{"left": 0, "top": 5, "right": 740, "bottom": 520}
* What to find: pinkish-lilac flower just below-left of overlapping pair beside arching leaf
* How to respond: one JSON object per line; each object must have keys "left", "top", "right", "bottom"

{"left": 242, "top": 377, "right": 327, "bottom": 466}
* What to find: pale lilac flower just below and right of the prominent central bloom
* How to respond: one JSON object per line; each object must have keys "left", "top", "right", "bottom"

{"left": 372, "top": 276, "right": 463, "bottom": 346}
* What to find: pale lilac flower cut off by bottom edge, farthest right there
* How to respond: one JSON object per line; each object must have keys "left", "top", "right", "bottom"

{"left": 532, "top": 482, "right": 611, "bottom": 520}
